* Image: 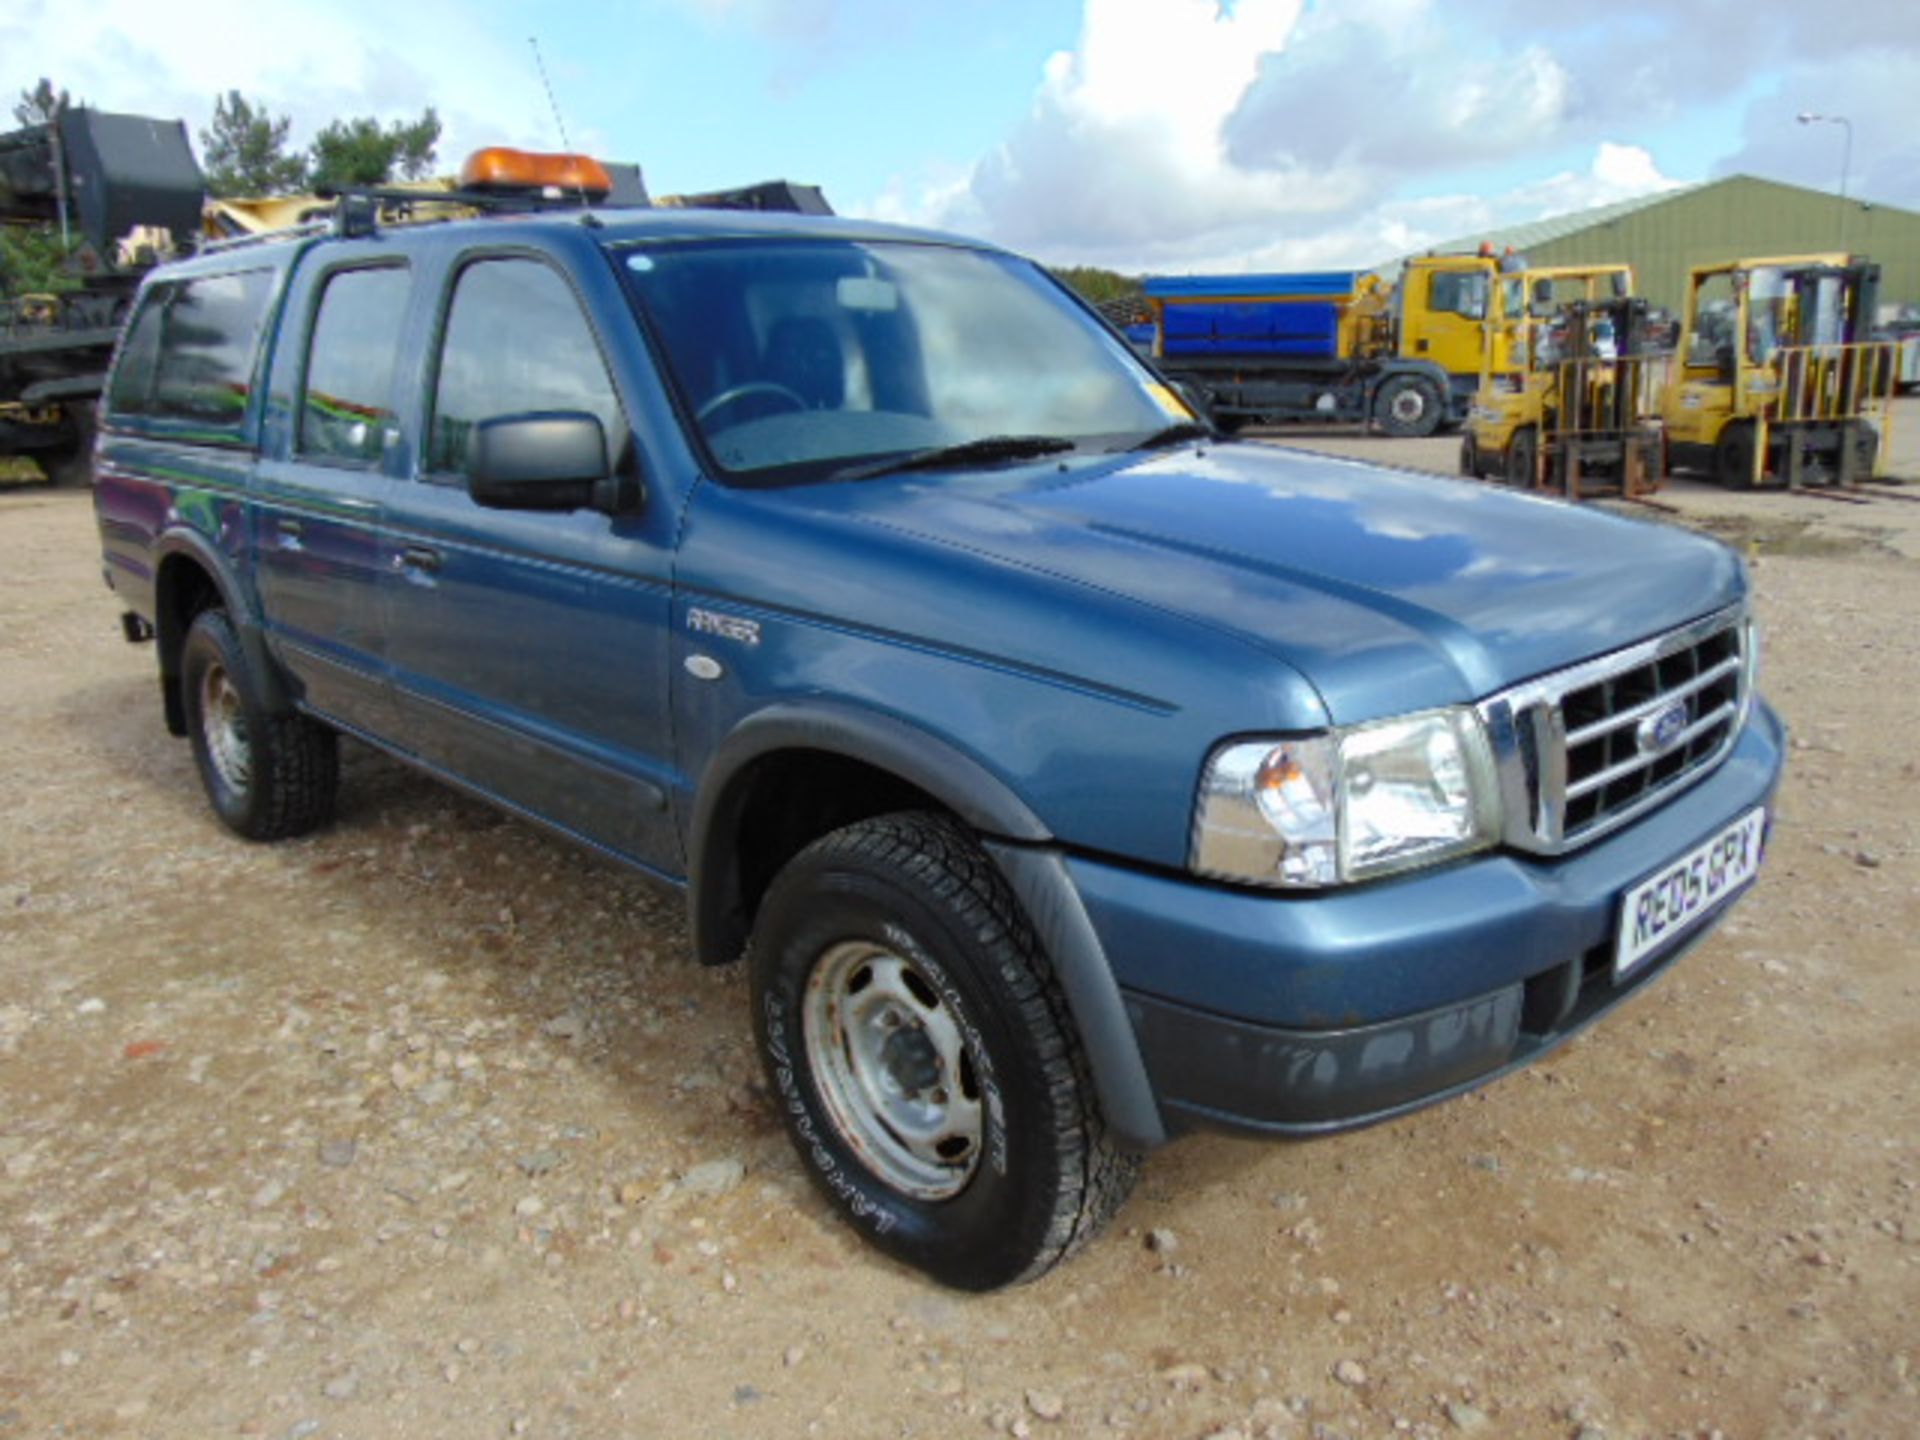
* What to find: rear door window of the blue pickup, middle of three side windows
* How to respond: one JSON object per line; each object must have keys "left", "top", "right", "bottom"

{"left": 296, "top": 265, "right": 409, "bottom": 465}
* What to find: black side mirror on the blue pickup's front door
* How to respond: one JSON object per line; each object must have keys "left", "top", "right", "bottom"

{"left": 467, "top": 411, "right": 637, "bottom": 513}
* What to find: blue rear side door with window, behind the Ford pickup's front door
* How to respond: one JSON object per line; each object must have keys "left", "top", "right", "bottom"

{"left": 255, "top": 253, "right": 413, "bottom": 735}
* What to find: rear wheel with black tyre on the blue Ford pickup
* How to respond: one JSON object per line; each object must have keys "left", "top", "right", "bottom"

{"left": 180, "top": 609, "right": 340, "bottom": 841}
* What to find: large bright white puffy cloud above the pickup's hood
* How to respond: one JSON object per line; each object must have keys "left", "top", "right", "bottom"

{"left": 860, "top": 0, "right": 1668, "bottom": 271}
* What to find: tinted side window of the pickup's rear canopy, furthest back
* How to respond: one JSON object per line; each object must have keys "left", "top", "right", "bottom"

{"left": 108, "top": 271, "right": 273, "bottom": 440}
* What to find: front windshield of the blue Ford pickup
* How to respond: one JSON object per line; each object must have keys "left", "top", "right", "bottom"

{"left": 614, "top": 238, "right": 1192, "bottom": 484}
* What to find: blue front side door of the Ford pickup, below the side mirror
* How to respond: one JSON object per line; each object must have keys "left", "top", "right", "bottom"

{"left": 386, "top": 253, "right": 680, "bottom": 874}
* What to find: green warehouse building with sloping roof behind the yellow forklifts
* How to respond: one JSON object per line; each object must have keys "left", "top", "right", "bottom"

{"left": 1423, "top": 175, "right": 1920, "bottom": 313}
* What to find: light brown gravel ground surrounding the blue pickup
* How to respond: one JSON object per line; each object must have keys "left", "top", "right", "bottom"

{"left": 0, "top": 426, "right": 1920, "bottom": 1440}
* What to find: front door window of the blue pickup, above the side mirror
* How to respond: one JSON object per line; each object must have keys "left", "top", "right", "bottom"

{"left": 426, "top": 259, "right": 626, "bottom": 474}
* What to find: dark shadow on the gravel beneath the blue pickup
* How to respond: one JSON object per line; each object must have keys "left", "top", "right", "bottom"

{"left": 61, "top": 676, "right": 1290, "bottom": 1275}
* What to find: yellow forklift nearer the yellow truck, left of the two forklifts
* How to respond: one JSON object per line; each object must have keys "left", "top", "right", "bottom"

{"left": 1459, "top": 265, "right": 1663, "bottom": 499}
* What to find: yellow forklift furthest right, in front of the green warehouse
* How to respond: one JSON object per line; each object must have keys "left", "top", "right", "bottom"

{"left": 1659, "top": 253, "right": 1899, "bottom": 490}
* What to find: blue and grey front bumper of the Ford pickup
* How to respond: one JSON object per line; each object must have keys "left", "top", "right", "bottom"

{"left": 1071, "top": 703, "right": 1786, "bottom": 1135}
